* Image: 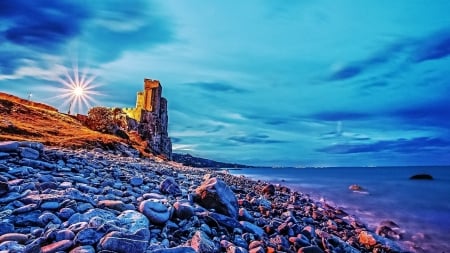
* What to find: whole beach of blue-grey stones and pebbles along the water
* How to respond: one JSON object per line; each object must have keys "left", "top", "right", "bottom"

{"left": 0, "top": 141, "right": 405, "bottom": 253}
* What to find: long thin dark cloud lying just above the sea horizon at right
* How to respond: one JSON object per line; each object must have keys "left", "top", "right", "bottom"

{"left": 317, "top": 137, "right": 450, "bottom": 154}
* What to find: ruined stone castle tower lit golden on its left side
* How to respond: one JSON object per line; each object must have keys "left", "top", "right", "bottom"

{"left": 122, "top": 78, "right": 172, "bottom": 159}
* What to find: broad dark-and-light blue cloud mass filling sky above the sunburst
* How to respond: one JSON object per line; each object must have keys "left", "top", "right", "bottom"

{"left": 0, "top": 0, "right": 173, "bottom": 74}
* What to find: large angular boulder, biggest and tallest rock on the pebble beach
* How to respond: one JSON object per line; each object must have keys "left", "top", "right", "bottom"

{"left": 195, "top": 177, "right": 238, "bottom": 219}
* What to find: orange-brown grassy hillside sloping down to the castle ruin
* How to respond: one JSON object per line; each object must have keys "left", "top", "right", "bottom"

{"left": 0, "top": 92, "right": 150, "bottom": 154}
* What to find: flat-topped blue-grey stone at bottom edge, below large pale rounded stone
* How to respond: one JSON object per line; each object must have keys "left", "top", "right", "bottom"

{"left": 98, "top": 229, "right": 150, "bottom": 253}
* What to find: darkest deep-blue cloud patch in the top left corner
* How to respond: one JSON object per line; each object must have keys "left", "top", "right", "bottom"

{"left": 0, "top": 0, "right": 90, "bottom": 52}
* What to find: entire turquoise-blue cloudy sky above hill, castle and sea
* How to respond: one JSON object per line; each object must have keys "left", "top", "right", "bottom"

{"left": 0, "top": 0, "right": 450, "bottom": 166}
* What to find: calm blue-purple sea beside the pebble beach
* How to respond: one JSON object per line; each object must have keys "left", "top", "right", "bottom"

{"left": 230, "top": 166, "right": 450, "bottom": 253}
